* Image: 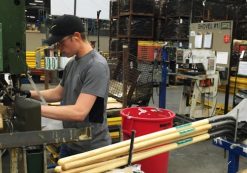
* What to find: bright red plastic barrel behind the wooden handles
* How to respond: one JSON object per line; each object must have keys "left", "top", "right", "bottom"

{"left": 120, "top": 107, "right": 175, "bottom": 173}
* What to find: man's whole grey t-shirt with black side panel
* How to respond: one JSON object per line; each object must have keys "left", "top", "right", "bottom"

{"left": 60, "top": 50, "right": 111, "bottom": 152}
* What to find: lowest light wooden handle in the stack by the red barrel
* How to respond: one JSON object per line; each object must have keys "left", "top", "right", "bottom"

{"left": 81, "top": 133, "right": 210, "bottom": 173}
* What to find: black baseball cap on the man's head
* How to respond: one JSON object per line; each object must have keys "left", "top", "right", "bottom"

{"left": 44, "top": 15, "right": 84, "bottom": 45}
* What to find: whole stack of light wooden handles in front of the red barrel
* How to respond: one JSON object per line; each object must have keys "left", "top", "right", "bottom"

{"left": 55, "top": 119, "right": 212, "bottom": 173}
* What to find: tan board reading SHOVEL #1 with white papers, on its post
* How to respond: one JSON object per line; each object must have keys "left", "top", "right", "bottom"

{"left": 189, "top": 20, "right": 234, "bottom": 114}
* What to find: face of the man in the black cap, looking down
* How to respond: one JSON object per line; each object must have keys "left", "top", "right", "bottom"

{"left": 57, "top": 35, "right": 77, "bottom": 57}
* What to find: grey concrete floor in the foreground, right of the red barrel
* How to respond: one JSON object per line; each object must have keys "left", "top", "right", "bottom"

{"left": 168, "top": 140, "right": 247, "bottom": 173}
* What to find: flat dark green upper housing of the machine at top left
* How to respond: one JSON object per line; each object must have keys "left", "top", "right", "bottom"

{"left": 0, "top": 0, "right": 27, "bottom": 75}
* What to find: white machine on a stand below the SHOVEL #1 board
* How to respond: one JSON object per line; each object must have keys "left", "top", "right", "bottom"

{"left": 176, "top": 49, "right": 219, "bottom": 119}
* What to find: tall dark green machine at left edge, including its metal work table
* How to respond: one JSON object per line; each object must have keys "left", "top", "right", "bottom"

{"left": 0, "top": 0, "right": 91, "bottom": 173}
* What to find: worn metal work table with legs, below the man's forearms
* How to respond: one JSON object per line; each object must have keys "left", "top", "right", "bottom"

{"left": 0, "top": 127, "right": 92, "bottom": 173}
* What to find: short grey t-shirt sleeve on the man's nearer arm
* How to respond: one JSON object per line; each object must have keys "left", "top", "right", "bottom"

{"left": 81, "top": 62, "right": 109, "bottom": 98}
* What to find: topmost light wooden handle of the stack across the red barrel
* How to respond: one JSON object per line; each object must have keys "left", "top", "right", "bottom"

{"left": 58, "top": 119, "right": 209, "bottom": 166}
